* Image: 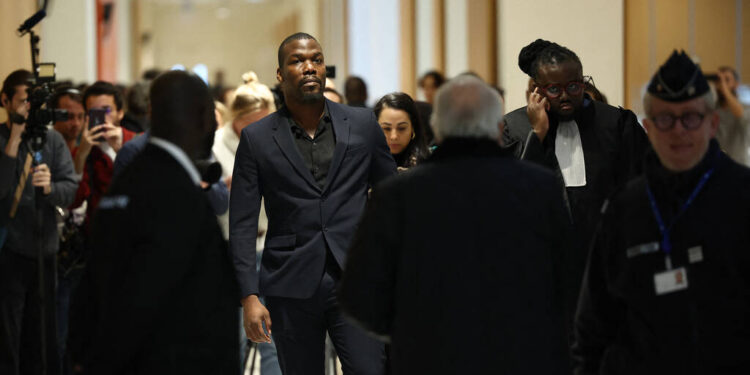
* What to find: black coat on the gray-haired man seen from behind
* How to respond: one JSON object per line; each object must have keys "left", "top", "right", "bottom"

{"left": 340, "top": 139, "right": 570, "bottom": 374}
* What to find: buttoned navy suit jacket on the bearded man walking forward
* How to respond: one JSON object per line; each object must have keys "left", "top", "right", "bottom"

{"left": 229, "top": 101, "right": 396, "bottom": 298}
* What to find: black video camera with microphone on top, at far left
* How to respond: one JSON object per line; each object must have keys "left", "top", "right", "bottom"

{"left": 11, "top": 6, "right": 68, "bottom": 151}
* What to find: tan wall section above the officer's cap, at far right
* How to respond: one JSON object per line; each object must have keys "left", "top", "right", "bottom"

{"left": 625, "top": 0, "right": 750, "bottom": 115}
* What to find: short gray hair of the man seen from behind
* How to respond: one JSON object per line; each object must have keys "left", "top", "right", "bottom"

{"left": 430, "top": 75, "right": 503, "bottom": 141}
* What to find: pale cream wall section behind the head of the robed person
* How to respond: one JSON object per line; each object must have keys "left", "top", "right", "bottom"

{"left": 498, "top": 0, "right": 624, "bottom": 112}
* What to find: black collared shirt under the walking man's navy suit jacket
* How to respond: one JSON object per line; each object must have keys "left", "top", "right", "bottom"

{"left": 286, "top": 105, "right": 336, "bottom": 189}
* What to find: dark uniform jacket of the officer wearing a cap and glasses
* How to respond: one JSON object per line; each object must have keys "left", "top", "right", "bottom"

{"left": 574, "top": 141, "right": 750, "bottom": 374}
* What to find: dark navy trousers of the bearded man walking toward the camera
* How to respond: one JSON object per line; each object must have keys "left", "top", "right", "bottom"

{"left": 266, "top": 271, "right": 385, "bottom": 375}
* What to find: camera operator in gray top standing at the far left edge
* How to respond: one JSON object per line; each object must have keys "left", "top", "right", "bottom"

{"left": 0, "top": 70, "right": 78, "bottom": 375}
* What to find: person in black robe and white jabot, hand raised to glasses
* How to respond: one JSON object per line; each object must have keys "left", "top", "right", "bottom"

{"left": 503, "top": 39, "right": 648, "bottom": 328}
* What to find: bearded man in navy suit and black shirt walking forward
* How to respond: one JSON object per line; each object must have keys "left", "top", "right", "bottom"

{"left": 229, "top": 33, "right": 396, "bottom": 375}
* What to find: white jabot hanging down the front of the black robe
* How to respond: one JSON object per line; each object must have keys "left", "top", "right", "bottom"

{"left": 555, "top": 120, "right": 586, "bottom": 187}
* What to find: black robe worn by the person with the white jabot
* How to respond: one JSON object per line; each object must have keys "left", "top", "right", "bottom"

{"left": 503, "top": 97, "right": 650, "bottom": 317}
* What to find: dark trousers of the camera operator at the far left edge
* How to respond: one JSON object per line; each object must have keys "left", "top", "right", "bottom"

{"left": 0, "top": 249, "right": 60, "bottom": 375}
